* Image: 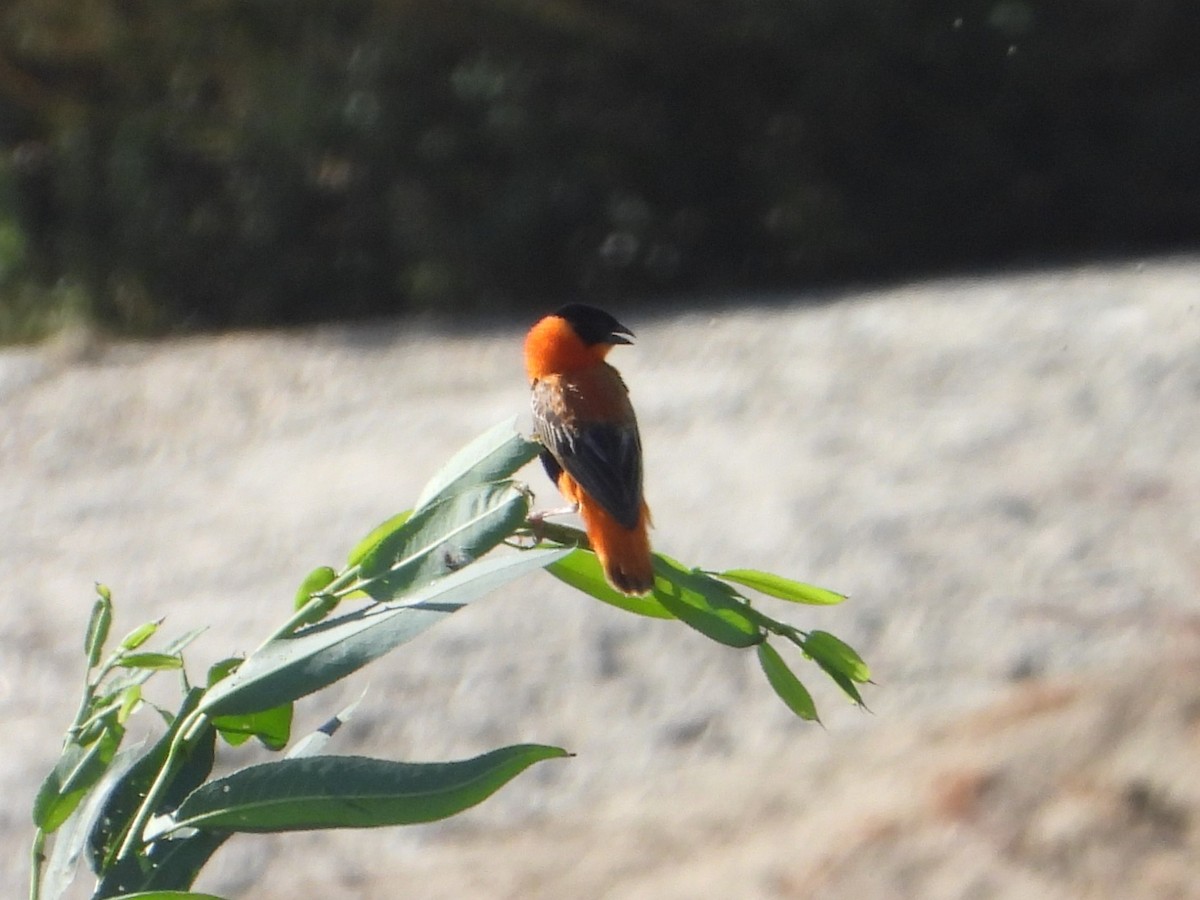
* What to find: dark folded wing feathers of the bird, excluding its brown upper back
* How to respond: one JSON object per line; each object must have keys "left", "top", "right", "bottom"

{"left": 533, "top": 385, "right": 642, "bottom": 528}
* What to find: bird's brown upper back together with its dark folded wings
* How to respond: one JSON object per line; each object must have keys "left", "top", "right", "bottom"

{"left": 533, "top": 366, "right": 642, "bottom": 528}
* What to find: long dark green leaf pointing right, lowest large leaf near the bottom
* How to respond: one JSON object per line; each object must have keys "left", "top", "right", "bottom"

{"left": 165, "top": 744, "right": 568, "bottom": 832}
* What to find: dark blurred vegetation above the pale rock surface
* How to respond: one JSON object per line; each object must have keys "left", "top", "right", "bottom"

{"left": 0, "top": 0, "right": 1200, "bottom": 340}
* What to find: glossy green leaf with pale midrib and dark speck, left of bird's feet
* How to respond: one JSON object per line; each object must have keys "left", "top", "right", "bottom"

{"left": 359, "top": 481, "right": 529, "bottom": 601}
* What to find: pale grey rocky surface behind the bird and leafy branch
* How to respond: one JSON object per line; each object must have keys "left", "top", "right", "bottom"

{"left": 0, "top": 258, "right": 1200, "bottom": 900}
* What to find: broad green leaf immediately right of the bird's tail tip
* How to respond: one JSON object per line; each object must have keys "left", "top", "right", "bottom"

{"left": 654, "top": 553, "right": 763, "bottom": 647}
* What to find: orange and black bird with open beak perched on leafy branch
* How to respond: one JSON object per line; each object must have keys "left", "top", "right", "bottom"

{"left": 524, "top": 304, "right": 654, "bottom": 594}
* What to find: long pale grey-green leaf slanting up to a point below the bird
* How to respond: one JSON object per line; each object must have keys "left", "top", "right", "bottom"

{"left": 202, "top": 548, "right": 570, "bottom": 715}
